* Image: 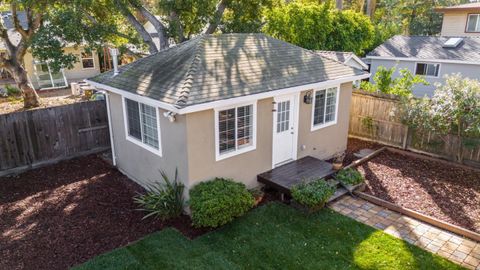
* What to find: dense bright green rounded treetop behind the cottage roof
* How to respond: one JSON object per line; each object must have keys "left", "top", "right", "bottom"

{"left": 263, "top": 2, "right": 375, "bottom": 55}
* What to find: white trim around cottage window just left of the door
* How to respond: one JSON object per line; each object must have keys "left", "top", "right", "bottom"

{"left": 214, "top": 100, "right": 257, "bottom": 161}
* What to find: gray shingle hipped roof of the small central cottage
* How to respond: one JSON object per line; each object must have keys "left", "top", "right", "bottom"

{"left": 90, "top": 34, "right": 366, "bottom": 108}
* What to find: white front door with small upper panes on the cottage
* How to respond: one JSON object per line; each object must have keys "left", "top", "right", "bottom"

{"left": 273, "top": 95, "right": 297, "bottom": 167}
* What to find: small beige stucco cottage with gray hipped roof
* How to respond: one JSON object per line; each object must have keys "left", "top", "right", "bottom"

{"left": 89, "top": 34, "right": 369, "bottom": 188}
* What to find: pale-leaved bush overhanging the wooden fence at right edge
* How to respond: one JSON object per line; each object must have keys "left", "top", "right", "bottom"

{"left": 402, "top": 74, "right": 480, "bottom": 162}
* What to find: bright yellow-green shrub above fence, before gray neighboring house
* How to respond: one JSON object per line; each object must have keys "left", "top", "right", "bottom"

{"left": 361, "top": 66, "right": 429, "bottom": 97}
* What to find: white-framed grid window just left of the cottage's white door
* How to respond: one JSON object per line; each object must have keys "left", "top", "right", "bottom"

{"left": 215, "top": 104, "right": 256, "bottom": 160}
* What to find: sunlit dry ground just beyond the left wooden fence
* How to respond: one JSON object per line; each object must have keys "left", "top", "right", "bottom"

{"left": 0, "top": 88, "right": 84, "bottom": 114}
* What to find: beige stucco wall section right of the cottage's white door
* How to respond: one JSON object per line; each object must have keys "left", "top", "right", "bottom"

{"left": 298, "top": 83, "right": 352, "bottom": 159}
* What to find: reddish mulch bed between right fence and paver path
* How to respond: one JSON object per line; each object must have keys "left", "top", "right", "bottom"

{"left": 348, "top": 142, "right": 480, "bottom": 233}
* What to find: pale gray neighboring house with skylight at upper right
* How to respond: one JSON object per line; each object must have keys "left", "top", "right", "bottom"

{"left": 367, "top": 3, "right": 480, "bottom": 96}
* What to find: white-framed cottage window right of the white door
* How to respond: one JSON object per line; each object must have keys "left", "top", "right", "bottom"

{"left": 312, "top": 87, "right": 339, "bottom": 130}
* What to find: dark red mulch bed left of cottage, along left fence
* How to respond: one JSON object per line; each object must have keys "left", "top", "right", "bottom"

{"left": 0, "top": 155, "right": 206, "bottom": 270}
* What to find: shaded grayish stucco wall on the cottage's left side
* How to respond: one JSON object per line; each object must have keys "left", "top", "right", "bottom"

{"left": 109, "top": 93, "right": 188, "bottom": 187}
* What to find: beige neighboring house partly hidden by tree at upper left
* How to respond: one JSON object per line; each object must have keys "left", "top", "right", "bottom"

{"left": 0, "top": 12, "right": 100, "bottom": 89}
